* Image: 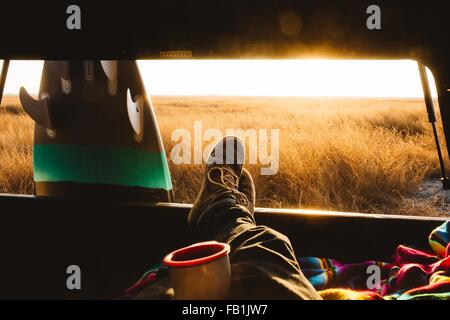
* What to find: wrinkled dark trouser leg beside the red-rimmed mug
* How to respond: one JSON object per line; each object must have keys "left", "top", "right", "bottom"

{"left": 201, "top": 200, "right": 321, "bottom": 299}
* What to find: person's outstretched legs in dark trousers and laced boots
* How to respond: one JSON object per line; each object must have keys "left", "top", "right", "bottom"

{"left": 188, "top": 137, "right": 321, "bottom": 299}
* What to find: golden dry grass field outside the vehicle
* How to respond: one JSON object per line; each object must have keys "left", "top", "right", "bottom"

{"left": 0, "top": 97, "right": 445, "bottom": 216}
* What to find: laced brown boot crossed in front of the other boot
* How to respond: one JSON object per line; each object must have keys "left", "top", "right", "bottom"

{"left": 188, "top": 137, "right": 251, "bottom": 231}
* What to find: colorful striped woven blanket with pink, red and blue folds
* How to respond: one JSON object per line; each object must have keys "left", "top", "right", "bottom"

{"left": 124, "top": 221, "right": 450, "bottom": 300}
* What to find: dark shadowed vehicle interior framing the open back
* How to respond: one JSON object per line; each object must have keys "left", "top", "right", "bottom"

{"left": 0, "top": 0, "right": 450, "bottom": 299}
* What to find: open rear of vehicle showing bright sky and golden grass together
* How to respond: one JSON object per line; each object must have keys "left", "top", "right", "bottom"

{"left": 0, "top": 60, "right": 450, "bottom": 216}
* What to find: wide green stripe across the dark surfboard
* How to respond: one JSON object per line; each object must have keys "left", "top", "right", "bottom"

{"left": 33, "top": 144, "right": 172, "bottom": 190}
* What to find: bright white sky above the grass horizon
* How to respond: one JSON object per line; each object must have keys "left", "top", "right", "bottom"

{"left": 0, "top": 60, "right": 436, "bottom": 98}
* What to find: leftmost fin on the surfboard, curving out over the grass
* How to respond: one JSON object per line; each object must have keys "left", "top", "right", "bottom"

{"left": 19, "top": 87, "right": 54, "bottom": 130}
